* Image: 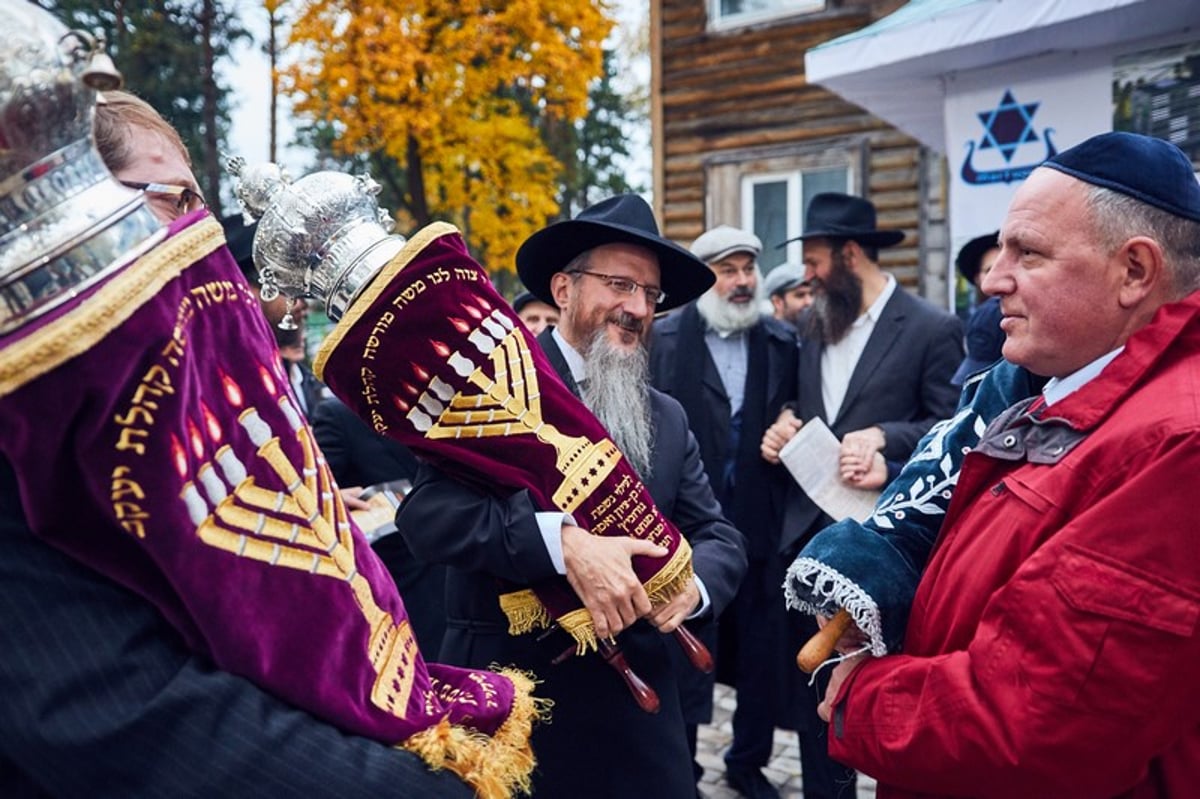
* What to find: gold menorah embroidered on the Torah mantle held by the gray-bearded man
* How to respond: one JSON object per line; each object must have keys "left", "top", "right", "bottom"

{"left": 409, "top": 311, "right": 620, "bottom": 512}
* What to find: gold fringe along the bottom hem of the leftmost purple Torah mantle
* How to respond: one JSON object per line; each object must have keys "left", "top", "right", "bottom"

{"left": 401, "top": 668, "right": 553, "bottom": 799}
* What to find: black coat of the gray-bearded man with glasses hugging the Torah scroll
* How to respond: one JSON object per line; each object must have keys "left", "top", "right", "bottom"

{"left": 397, "top": 331, "right": 745, "bottom": 799}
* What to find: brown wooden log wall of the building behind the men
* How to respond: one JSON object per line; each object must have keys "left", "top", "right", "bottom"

{"left": 650, "top": 0, "right": 947, "bottom": 298}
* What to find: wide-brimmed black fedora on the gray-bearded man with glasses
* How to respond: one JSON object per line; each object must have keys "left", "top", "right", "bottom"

{"left": 517, "top": 194, "right": 716, "bottom": 311}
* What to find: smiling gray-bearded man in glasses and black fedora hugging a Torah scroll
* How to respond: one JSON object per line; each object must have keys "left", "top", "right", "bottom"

{"left": 397, "top": 194, "right": 745, "bottom": 799}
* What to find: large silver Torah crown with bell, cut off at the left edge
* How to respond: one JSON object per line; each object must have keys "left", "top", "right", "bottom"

{"left": 0, "top": 0, "right": 162, "bottom": 337}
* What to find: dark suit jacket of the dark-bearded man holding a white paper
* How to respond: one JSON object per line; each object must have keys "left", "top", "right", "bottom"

{"left": 781, "top": 287, "right": 962, "bottom": 555}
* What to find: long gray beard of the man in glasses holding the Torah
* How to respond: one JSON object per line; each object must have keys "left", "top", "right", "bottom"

{"left": 581, "top": 328, "right": 654, "bottom": 480}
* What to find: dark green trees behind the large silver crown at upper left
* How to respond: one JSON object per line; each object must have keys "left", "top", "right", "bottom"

{"left": 37, "top": 0, "right": 248, "bottom": 214}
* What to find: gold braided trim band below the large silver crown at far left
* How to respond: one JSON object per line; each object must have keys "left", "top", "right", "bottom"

{"left": 0, "top": 216, "right": 224, "bottom": 397}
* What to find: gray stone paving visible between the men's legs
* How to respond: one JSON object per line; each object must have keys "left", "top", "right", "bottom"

{"left": 696, "top": 685, "right": 875, "bottom": 799}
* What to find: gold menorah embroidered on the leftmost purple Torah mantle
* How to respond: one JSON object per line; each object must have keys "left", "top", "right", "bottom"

{"left": 180, "top": 395, "right": 416, "bottom": 719}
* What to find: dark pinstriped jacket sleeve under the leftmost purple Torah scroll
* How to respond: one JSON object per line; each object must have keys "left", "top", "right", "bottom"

{"left": 0, "top": 458, "right": 474, "bottom": 799}
